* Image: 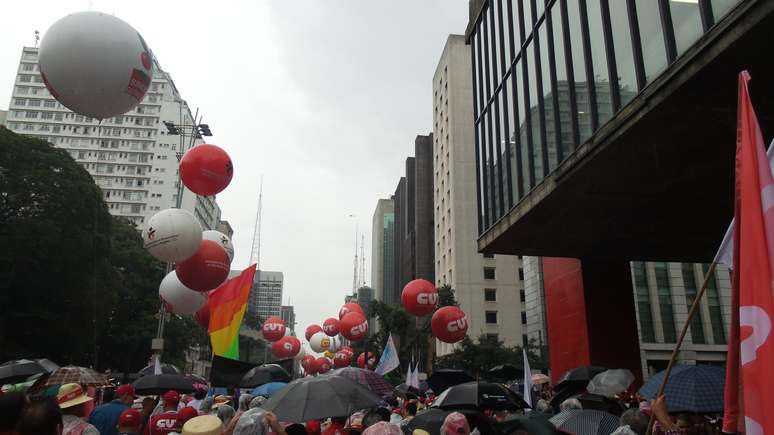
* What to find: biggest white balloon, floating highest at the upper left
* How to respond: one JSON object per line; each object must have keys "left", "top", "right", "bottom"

{"left": 38, "top": 11, "right": 153, "bottom": 119}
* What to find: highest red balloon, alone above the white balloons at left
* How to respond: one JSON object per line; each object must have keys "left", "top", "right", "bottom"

{"left": 180, "top": 144, "right": 234, "bottom": 196}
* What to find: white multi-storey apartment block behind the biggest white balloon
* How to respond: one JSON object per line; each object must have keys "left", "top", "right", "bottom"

{"left": 6, "top": 47, "right": 221, "bottom": 229}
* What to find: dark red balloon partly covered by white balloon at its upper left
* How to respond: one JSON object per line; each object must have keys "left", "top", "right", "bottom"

{"left": 175, "top": 240, "right": 231, "bottom": 292}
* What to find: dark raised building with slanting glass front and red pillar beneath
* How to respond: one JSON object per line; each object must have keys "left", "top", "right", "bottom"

{"left": 465, "top": 0, "right": 774, "bottom": 379}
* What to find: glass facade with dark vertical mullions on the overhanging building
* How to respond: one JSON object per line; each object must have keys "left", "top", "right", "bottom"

{"left": 468, "top": 0, "right": 740, "bottom": 234}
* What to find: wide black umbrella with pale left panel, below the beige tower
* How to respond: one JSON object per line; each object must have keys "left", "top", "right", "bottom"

{"left": 433, "top": 381, "right": 530, "bottom": 411}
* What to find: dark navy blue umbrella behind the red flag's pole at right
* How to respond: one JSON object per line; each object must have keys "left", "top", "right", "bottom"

{"left": 640, "top": 365, "right": 726, "bottom": 414}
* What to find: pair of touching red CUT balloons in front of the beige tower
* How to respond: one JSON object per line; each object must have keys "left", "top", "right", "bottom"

{"left": 400, "top": 279, "right": 468, "bottom": 343}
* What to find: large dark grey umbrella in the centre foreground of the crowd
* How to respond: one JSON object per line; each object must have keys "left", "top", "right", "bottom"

{"left": 262, "top": 376, "right": 381, "bottom": 423}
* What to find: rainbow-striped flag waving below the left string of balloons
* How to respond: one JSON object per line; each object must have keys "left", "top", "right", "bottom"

{"left": 207, "top": 264, "right": 255, "bottom": 359}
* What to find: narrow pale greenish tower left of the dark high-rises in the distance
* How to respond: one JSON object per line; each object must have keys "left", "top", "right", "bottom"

{"left": 371, "top": 198, "right": 397, "bottom": 305}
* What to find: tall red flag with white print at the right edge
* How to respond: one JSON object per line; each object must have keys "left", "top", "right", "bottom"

{"left": 723, "top": 71, "right": 774, "bottom": 435}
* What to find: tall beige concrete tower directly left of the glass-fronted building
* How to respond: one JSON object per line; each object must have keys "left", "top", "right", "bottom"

{"left": 432, "top": 35, "right": 524, "bottom": 355}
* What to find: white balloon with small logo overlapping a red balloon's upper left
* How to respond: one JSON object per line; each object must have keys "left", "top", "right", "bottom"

{"left": 142, "top": 208, "right": 202, "bottom": 263}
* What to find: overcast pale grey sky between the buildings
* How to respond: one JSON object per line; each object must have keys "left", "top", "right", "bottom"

{"left": 0, "top": 0, "right": 468, "bottom": 346}
